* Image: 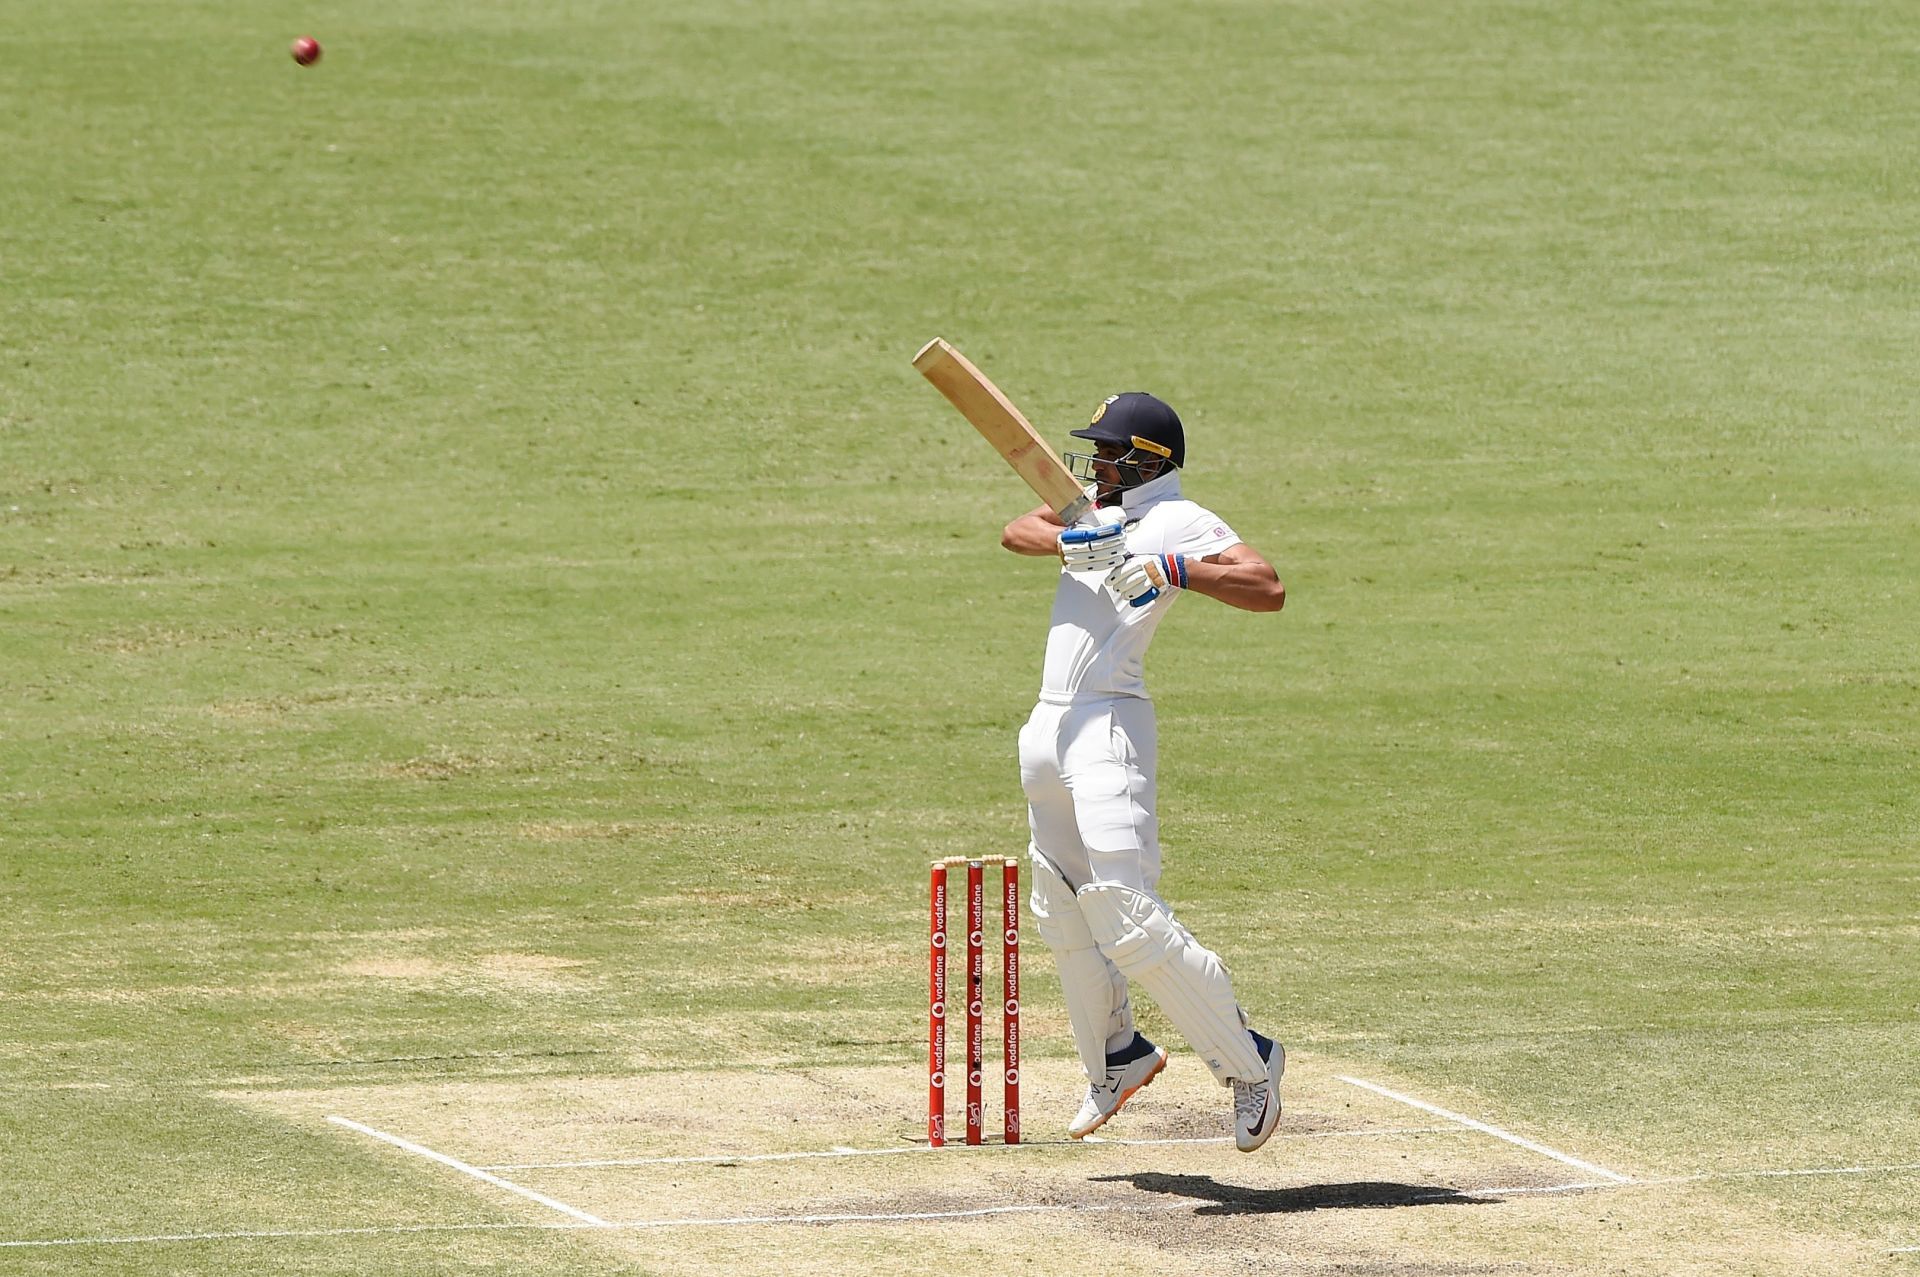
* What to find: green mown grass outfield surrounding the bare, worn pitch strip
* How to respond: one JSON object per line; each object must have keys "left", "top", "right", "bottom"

{"left": 0, "top": 0, "right": 1920, "bottom": 1273}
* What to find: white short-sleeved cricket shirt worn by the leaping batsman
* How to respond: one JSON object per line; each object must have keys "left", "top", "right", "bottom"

{"left": 1041, "top": 470, "right": 1240, "bottom": 705}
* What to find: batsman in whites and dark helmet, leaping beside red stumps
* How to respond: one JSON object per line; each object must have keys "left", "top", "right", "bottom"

{"left": 1000, "top": 392, "right": 1286, "bottom": 1152}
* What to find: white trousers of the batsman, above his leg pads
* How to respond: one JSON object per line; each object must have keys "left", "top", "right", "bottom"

{"left": 1020, "top": 697, "right": 1160, "bottom": 891}
